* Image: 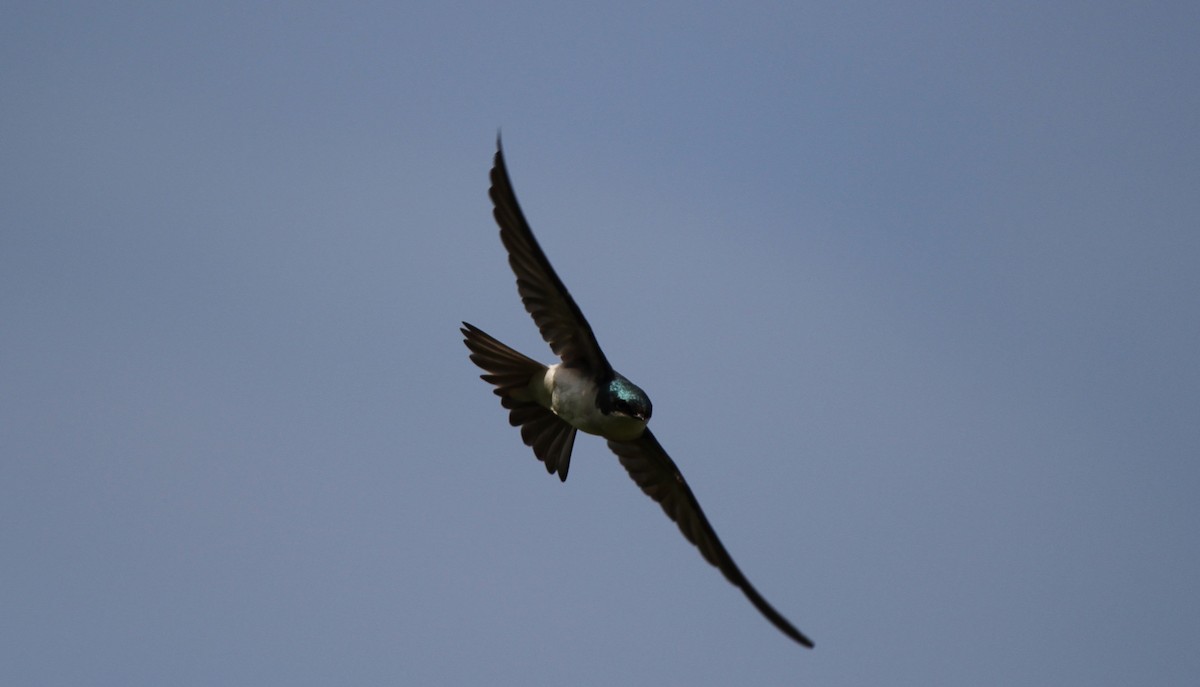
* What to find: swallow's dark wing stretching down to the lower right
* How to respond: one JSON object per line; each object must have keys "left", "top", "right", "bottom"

{"left": 608, "top": 430, "right": 812, "bottom": 649}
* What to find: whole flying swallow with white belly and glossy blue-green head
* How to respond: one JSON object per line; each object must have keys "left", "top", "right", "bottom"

{"left": 462, "top": 138, "right": 812, "bottom": 649}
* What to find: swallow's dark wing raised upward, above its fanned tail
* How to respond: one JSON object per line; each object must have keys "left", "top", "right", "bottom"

{"left": 487, "top": 137, "right": 612, "bottom": 377}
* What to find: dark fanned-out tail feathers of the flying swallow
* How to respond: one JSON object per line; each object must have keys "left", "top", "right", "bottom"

{"left": 462, "top": 322, "right": 576, "bottom": 482}
